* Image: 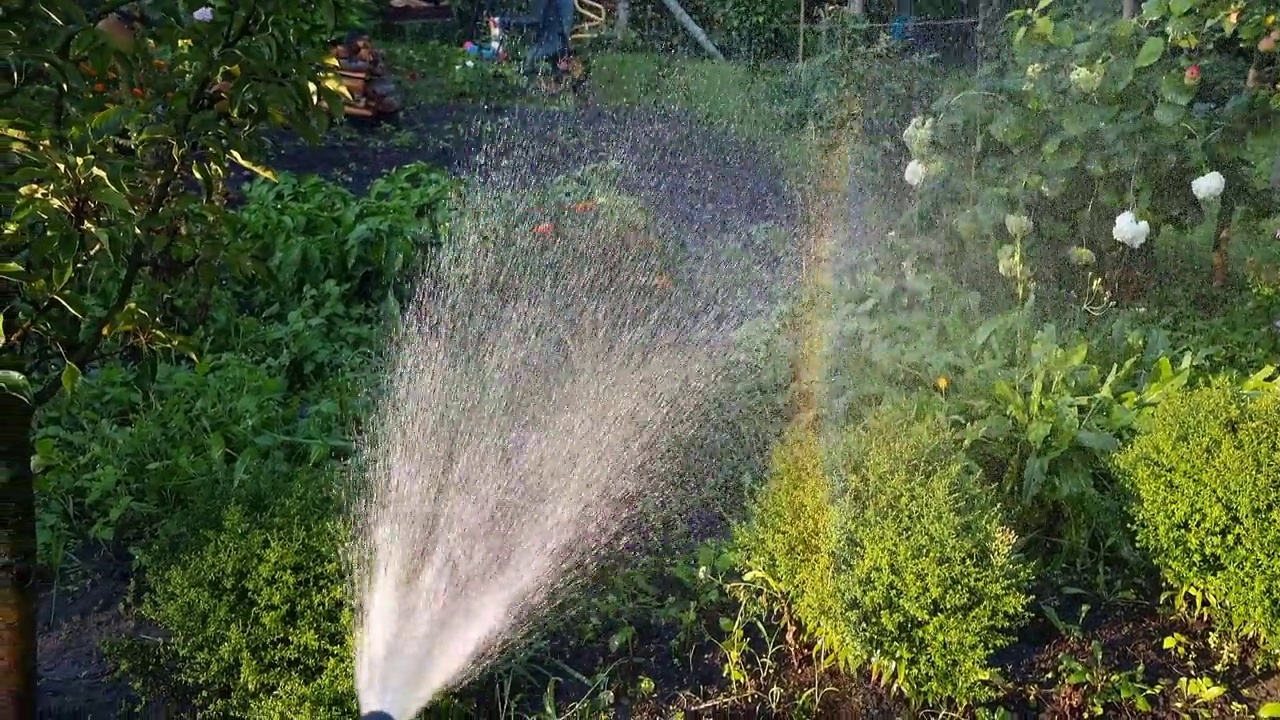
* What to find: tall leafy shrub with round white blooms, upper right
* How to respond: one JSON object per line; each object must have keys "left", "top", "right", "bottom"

{"left": 902, "top": 0, "right": 1280, "bottom": 294}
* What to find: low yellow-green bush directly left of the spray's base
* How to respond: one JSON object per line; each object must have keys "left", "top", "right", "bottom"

{"left": 115, "top": 479, "right": 356, "bottom": 720}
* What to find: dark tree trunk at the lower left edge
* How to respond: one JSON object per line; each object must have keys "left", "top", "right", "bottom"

{"left": 0, "top": 392, "right": 36, "bottom": 720}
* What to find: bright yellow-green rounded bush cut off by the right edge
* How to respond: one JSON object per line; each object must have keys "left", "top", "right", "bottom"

{"left": 1115, "top": 379, "right": 1280, "bottom": 644}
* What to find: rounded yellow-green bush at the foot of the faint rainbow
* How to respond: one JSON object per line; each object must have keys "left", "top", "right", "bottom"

{"left": 740, "top": 397, "right": 1029, "bottom": 706}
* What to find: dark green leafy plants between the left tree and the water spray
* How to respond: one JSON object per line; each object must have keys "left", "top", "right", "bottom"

{"left": 35, "top": 159, "right": 453, "bottom": 568}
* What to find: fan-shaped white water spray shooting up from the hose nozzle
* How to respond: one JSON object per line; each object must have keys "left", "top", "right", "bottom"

{"left": 353, "top": 131, "right": 788, "bottom": 720}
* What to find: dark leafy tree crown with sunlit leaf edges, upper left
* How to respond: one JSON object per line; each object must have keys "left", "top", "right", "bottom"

{"left": 0, "top": 0, "right": 340, "bottom": 405}
